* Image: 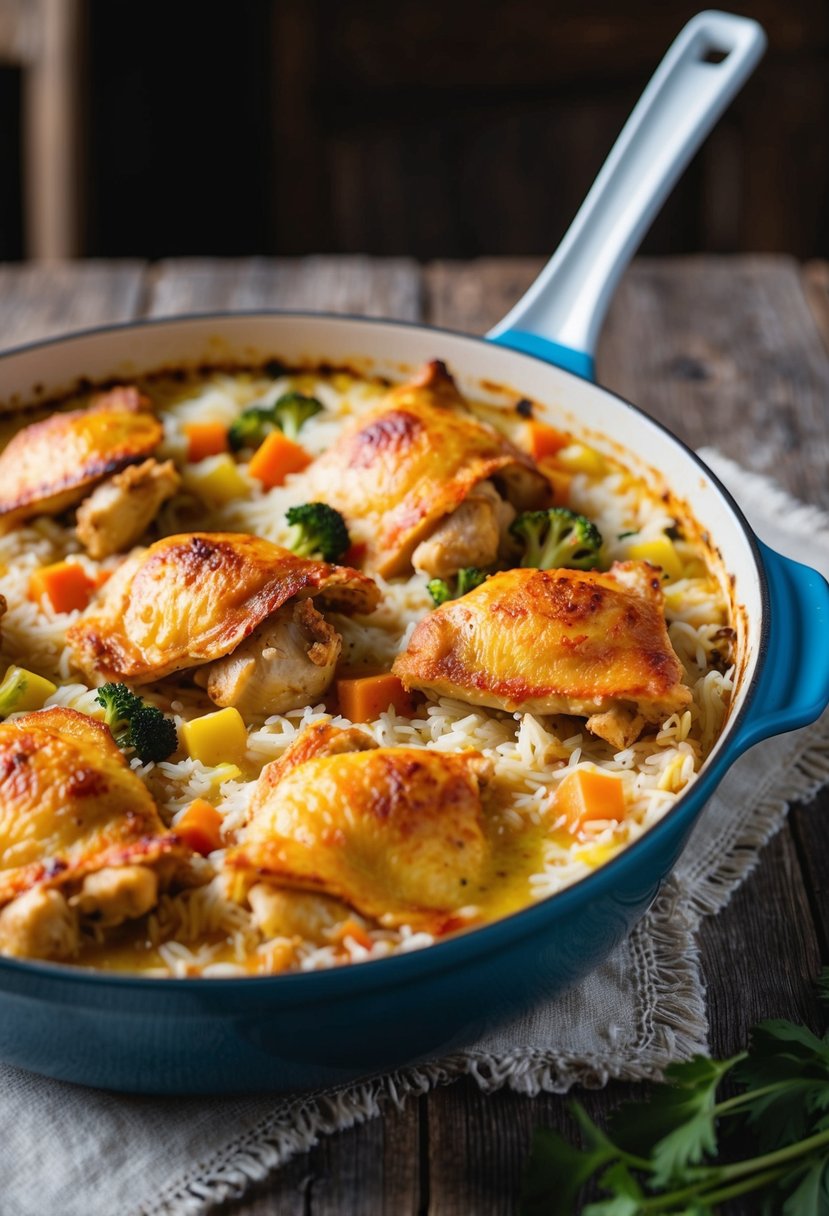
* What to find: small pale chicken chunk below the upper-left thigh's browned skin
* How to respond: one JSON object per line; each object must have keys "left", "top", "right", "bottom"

{"left": 78, "top": 460, "right": 181, "bottom": 561}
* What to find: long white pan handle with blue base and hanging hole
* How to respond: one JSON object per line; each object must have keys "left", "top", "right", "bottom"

{"left": 486, "top": 11, "right": 766, "bottom": 379}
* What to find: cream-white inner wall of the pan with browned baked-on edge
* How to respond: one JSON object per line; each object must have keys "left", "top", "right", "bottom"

{"left": 0, "top": 314, "right": 763, "bottom": 768}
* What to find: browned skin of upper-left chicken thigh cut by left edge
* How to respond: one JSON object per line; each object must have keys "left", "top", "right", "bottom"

{"left": 0, "top": 385, "right": 164, "bottom": 528}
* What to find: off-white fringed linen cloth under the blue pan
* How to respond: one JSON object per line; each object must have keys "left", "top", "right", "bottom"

{"left": 0, "top": 451, "right": 829, "bottom": 1216}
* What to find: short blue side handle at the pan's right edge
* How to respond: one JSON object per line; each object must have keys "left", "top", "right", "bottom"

{"left": 734, "top": 541, "right": 829, "bottom": 751}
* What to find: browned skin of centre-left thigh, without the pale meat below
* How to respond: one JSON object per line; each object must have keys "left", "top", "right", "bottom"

{"left": 67, "top": 533, "right": 379, "bottom": 685}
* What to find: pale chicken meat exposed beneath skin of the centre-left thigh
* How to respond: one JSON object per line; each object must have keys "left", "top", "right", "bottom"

{"left": 196, "top": 599, "right": 343, "bottom": 716}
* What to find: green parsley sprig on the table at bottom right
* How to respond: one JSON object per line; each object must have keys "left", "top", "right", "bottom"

{"left": 521, "top": 972, "right": 829, "bottom": 1216}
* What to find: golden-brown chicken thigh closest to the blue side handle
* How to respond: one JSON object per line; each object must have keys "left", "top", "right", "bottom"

{"left": 394, "top": 562, "right": 692, "bottom": 747}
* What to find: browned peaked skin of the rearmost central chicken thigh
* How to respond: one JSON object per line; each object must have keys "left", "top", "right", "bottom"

{"left": 308, "top": 361, "right": 549, "bottom": 578}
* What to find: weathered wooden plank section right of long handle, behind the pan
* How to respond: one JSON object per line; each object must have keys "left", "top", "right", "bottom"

{"left": 597, "top": 257, "right": 829, "bottom": 506}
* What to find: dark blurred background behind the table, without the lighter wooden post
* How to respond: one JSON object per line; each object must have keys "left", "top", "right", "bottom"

{"left": 0, "top": 0, "right": 829, "bottom": 259}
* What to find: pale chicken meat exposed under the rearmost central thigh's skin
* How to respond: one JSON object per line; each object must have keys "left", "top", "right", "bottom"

{"left": 412, "top": 482, "right": 515, "bottom": 579}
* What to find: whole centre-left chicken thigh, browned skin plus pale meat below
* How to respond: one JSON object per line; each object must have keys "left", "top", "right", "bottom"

{"left": 67, "top": 533, "right": 379, "bottom": 715}
